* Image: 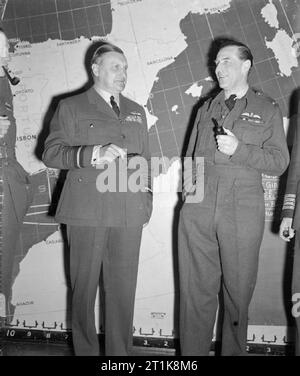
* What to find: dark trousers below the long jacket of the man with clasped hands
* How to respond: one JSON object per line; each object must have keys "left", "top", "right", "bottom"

{"left": 68, "top": 226, "right": 142, "bottom": 356}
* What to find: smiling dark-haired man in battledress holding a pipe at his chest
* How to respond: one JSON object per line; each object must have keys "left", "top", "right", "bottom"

{"left": 179, "top": 40, "right": 289, "bottom": 355}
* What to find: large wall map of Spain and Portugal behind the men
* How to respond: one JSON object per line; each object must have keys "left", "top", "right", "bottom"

{"left": 0, "top": 0, "right": 300, "bottom": 343}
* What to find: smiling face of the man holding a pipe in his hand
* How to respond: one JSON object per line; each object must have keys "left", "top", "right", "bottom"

{"left": 216, "top": 46, "right": 250, "bottom": 92}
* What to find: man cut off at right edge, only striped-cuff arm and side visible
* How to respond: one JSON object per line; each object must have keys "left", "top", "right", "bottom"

{"left": 279, "top": 99, "right": 300, "bottom": 356}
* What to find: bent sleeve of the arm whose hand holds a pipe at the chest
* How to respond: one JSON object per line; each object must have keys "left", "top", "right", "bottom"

{"left": 231, "top": 104, "right": 289, "bottom": 176}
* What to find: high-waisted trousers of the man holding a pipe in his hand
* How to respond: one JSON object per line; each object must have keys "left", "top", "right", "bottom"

{"left": 179, "top": 168, "right": 265, "bottom": 356}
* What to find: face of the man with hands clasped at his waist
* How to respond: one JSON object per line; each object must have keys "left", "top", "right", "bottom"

{"left": 92, "top": 52, "right": 128, "bottom": 95}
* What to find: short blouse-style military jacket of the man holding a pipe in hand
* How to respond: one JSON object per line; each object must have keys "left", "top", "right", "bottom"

{"left": 186, "top": 88, "right": 289, "bottom": 176}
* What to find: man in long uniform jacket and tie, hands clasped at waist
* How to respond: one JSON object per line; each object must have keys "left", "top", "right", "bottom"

{"left": 43, "top": 44, "right": 152, "bottom": 356}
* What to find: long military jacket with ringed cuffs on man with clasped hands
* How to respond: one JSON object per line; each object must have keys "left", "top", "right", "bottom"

{"left": 43, "top": 88, "right": 152, "bottom": 227}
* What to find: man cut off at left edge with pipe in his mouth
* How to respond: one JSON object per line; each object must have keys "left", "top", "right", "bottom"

{"left": 0, "top": 29, "right": 30, "bottom": 324}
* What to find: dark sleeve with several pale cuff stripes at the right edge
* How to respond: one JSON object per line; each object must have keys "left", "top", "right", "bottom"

{"left": 281, "top": 115, "right": 300, "bottom": 218}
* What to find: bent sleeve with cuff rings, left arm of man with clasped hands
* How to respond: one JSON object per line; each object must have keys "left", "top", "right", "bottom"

{"left": 42, "top": 101, "right": 94, "bottom": 170}
